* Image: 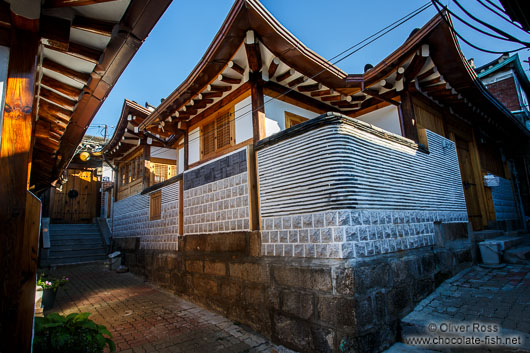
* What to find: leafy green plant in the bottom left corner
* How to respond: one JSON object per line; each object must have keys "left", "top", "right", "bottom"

{"left": 33, "top": 313, "right": 116, "bottom": 353}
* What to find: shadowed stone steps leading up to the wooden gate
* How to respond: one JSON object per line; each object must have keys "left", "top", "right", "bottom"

{"left": 45, "top": 224, "right": 107, "bottom": 266}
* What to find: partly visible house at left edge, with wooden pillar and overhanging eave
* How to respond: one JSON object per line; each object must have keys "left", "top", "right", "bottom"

{"left": 0, "top": 0, "right": 170, "bottom": 353}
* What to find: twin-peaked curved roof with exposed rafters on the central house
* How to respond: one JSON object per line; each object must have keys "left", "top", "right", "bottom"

{"left": 131, "top": 0, "right": 528, "bottom": 148}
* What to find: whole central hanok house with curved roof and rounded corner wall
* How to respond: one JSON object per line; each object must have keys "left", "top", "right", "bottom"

{"left": 106, "top": 0, "right": 529, "bottom": 352}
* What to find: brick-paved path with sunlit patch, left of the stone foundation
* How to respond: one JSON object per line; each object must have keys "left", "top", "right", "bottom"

{"left": 46, "top": 263, "right": 288, "bottom": 353}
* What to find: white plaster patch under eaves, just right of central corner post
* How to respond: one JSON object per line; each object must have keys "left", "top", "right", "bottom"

{"left": 265, "top": 96, "right": 319, "bottom": 136}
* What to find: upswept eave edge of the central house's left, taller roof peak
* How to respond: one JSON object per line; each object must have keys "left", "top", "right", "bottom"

{"left": 139, "top": 0, "right": 347, "bottom": 129}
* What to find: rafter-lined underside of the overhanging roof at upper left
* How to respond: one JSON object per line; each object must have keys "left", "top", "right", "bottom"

{"left": 0, "top": 0, "right": 171, "bottom": 190}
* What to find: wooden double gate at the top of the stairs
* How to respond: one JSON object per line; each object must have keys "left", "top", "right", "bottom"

{"left": 51, "top": 169, "right": 100, "bottom": 223}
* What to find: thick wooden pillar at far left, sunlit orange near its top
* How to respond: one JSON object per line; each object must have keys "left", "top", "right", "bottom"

{"left": 0, "top": 29, "right": 40, "bottom": 353}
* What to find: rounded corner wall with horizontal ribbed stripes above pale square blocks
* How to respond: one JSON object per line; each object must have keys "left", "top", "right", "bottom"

{"left": 258, "top": 118, "right": 467, "bottom": 258}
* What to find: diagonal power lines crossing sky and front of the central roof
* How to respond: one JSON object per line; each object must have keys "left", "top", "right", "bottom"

{"left": 159, "top": 3, "right": 432, "bottom": 147}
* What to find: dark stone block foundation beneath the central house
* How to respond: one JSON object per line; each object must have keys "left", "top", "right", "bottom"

{"left": 114, "top": 232, "right": 471, "bottom": 352}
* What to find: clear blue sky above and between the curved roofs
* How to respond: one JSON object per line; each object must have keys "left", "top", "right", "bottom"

{"left": 87, "top": 0, "right": 530, "bottom": 135}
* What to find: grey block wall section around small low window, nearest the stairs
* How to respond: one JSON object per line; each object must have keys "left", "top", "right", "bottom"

{"left": 111, "top": 182, "right": 179, "bottom": 250}
